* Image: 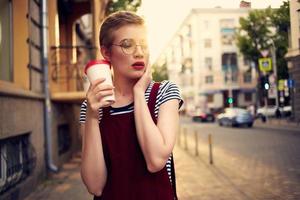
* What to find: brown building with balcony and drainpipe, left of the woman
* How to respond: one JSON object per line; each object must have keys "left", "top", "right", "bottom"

{"left": 0, "top": 0, "right": 104, "bottom": 200}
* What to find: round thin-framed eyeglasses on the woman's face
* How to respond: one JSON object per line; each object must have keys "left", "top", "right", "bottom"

{"left": 112, "top": 39, "right": 148, "bottom": 55}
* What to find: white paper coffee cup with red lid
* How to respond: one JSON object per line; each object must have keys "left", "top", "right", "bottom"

{"left": 84, "top": 60, "right": 115, "bottom": 105}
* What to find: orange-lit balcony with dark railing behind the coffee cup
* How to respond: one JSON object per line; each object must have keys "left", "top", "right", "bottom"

{"left": 49, "top": 45, "right": 98, "bottom": 103}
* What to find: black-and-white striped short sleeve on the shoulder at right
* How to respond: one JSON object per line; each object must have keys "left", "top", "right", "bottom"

{"left": 157, "top": 81, "right": 183, "bottom": 109}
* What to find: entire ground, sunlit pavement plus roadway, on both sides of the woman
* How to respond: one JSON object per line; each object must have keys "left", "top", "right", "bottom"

{"left": 26, "top": 118, "right": 300, "bottom": 200}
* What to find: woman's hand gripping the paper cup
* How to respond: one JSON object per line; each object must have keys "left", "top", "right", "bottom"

{"left": 86, "top": 78, "right": 114, "bottom": 114}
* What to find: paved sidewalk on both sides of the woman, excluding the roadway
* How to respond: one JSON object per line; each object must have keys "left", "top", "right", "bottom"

{"left": 25, "top": 137, "right": 300, "bottom": 200}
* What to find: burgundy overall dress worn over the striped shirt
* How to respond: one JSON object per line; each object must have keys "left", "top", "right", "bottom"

{"left": 94, "top": 82, "right": 174, "bottom": 200}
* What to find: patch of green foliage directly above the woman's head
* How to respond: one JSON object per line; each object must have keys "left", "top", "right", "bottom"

{"left": 105, "top": 0, "right": 141, "bottom": 16}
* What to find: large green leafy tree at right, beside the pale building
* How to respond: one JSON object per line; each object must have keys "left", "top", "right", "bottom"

{"left": 236, "top": 2, "right": 290, "bottom": 79}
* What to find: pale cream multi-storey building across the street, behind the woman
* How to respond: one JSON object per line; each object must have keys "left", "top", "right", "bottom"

{"left": 157, "top": 8, "right": 257, "bottom": 112}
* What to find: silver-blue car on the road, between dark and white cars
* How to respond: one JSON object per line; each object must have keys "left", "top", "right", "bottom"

{"left": 217, "top": 108, "right": 254, "bottom": 127}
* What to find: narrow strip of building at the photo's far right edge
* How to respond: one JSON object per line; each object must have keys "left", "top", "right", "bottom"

{"left": 286, "top": 0, "right": 300, "bottom": 123}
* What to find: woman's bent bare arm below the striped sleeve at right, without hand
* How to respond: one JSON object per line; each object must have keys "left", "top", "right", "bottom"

{"left": 134, "top": 90, "right": 179, "bottom": 172}
